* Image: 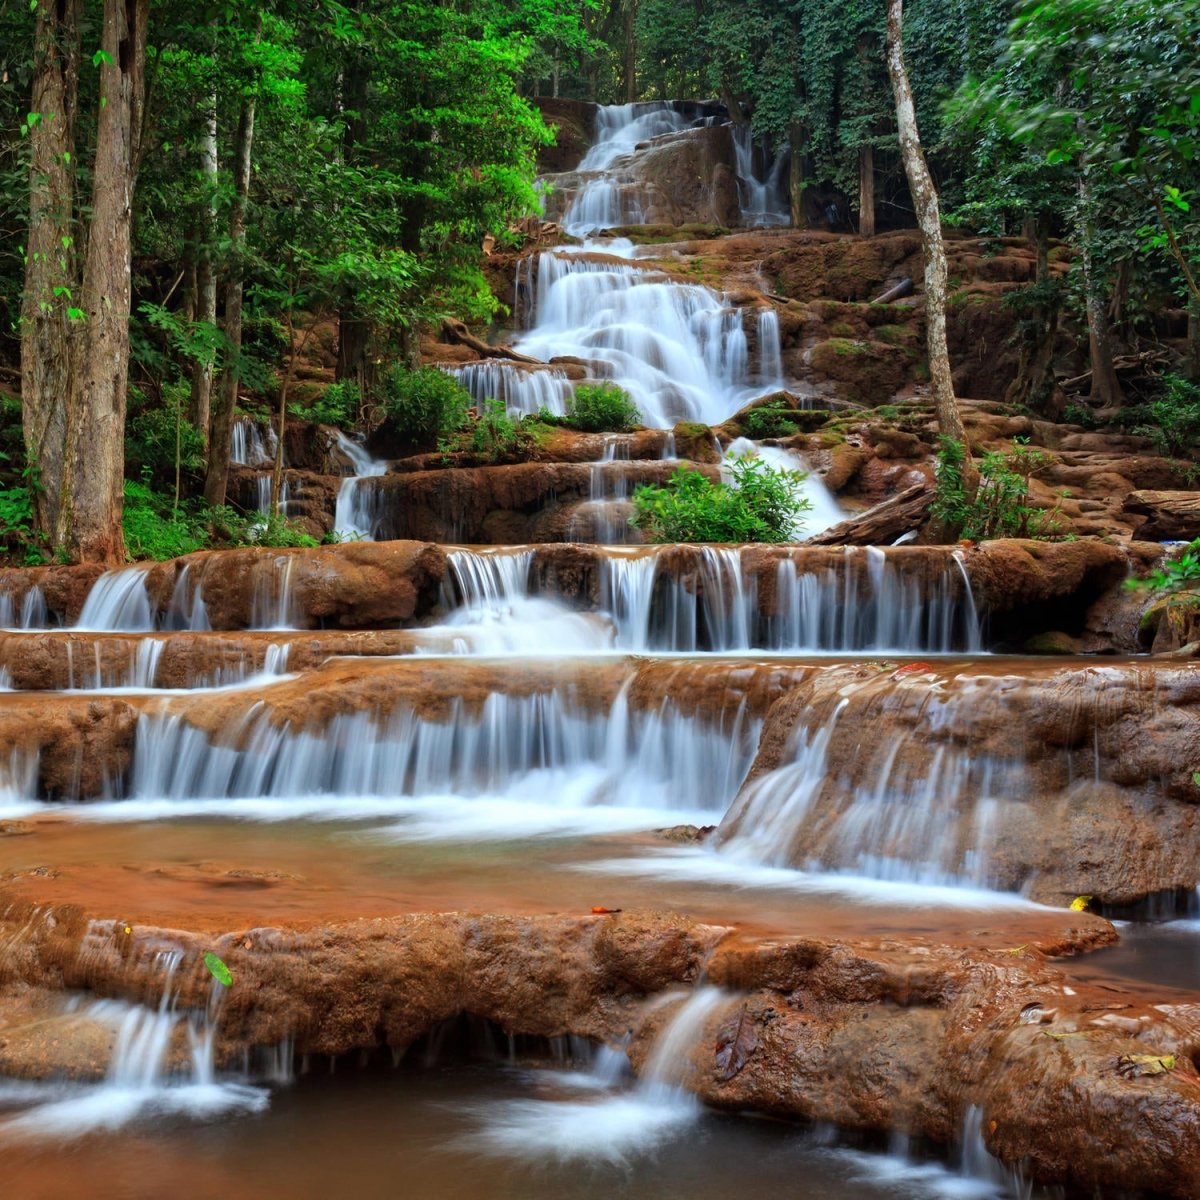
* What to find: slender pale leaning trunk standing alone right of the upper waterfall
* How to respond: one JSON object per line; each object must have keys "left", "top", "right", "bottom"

{"left": 888, "top": 0, "right": 979, "bottom": 525}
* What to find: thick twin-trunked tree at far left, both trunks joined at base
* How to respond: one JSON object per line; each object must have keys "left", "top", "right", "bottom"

{"left": 22, "top": 0, "right": 149, "bottom": 564}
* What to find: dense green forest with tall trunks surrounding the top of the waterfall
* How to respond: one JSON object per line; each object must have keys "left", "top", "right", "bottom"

{"left": 0, "top": 0, "right": 1200, "bottom": 562}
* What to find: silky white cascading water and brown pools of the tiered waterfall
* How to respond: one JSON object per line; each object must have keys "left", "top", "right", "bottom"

{"left": 0, "top": 96, "right": 1176, "bottom": 1200}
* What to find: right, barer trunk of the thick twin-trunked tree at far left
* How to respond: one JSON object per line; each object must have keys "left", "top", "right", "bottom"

{"left": 55, "top": 0, "right": 150, "bottom": 565}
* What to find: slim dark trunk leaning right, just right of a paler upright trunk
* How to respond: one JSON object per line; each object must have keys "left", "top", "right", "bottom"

{"left": 204, "top": 87, "right": 254, "bottom": 505}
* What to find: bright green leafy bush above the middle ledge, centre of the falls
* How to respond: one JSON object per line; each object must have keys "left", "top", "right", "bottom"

{"left": 630, "top": 458, "right": 810, "bottom": 542}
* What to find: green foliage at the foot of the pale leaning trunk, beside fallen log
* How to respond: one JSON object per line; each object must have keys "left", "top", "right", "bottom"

{"left": 930, "top": 438, "right": 1060, "bottom": 541}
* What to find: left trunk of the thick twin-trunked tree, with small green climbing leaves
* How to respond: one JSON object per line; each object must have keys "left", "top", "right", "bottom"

{"left": 20, "top": 0, "right": 82, "bottom": 542}
